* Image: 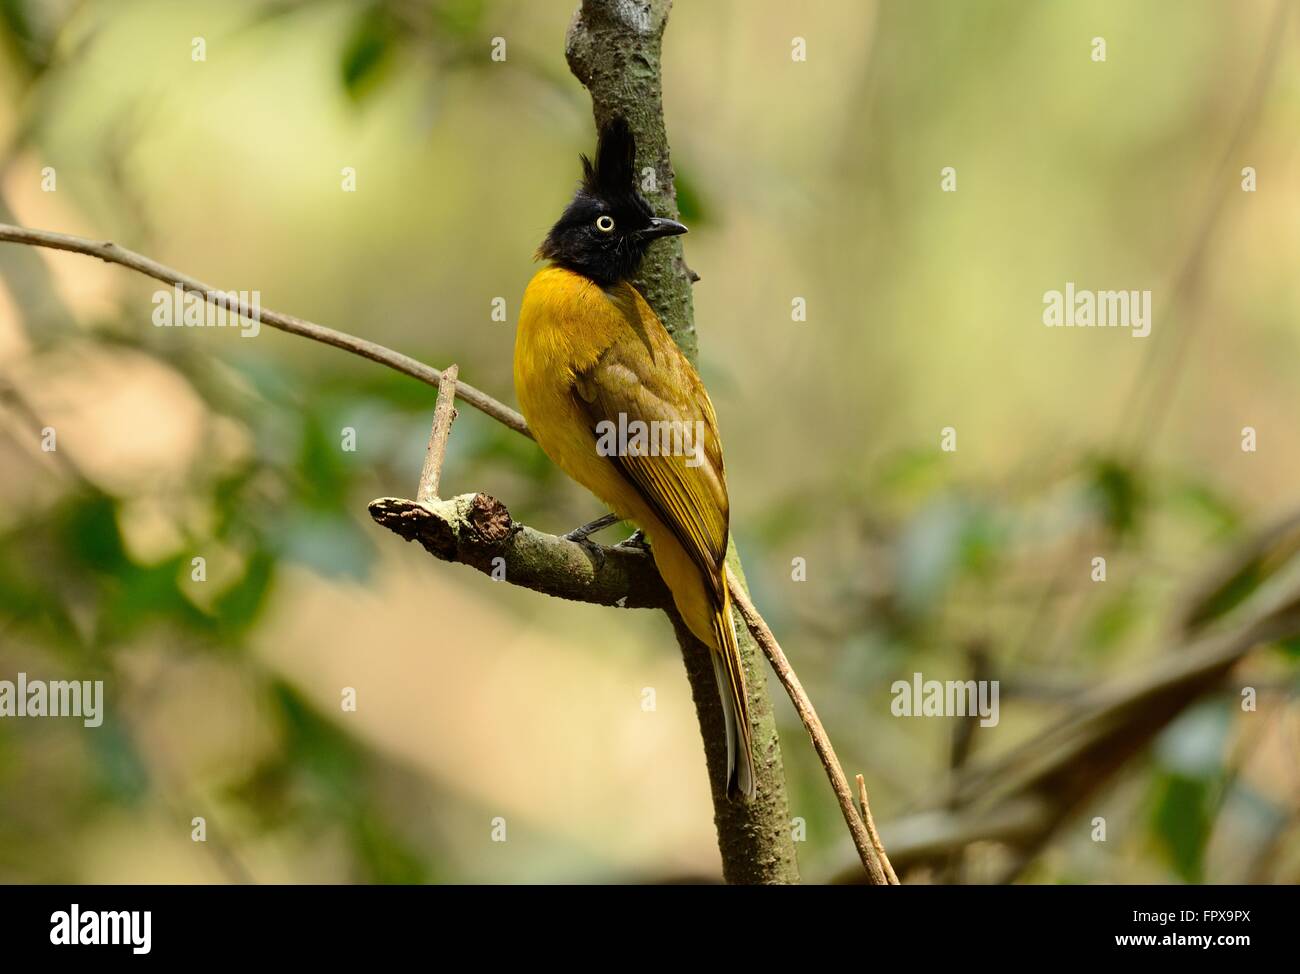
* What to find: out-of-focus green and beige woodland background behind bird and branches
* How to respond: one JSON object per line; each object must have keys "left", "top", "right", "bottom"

{"left": 0, "top": 0, "right": 1300, "bottom": 883}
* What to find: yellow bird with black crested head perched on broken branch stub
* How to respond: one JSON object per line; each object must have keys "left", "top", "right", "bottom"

{"left": 515, "top": 117, "right": 755, "bottom": 802}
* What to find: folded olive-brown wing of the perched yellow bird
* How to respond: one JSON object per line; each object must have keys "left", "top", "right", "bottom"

{"left": 575, "top": 322, "right": 729, "bottom": 596}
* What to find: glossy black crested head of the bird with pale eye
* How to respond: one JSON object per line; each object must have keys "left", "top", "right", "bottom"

{"left": 537, "top": 118, "right": 686, "bottom": 287}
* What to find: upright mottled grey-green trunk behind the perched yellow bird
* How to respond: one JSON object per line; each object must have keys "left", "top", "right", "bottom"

{"left": 566, "top": 0, "right": 798, "bottom": 883}
